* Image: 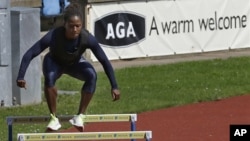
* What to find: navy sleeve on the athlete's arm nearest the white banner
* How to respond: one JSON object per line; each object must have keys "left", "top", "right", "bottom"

{"left": 88, "top": 34, "right": 118, "bottom": 89}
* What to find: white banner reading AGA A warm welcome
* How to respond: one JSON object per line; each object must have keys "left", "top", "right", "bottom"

{"left": 88, "top": 0, "right": 250, "bottom": 61}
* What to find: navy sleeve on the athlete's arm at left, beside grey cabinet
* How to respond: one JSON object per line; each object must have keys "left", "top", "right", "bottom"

{"left": 17, "top": 31, "right": 52, "bottom": 80}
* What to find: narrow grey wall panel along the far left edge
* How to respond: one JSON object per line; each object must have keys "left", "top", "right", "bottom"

{"left": 0, "top": 0, "right": 12, "bottom": 106}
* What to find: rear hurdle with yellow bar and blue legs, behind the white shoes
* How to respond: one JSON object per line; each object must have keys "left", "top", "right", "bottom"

{"left": 6, "top": 114, "right": 137, "bottom": 141}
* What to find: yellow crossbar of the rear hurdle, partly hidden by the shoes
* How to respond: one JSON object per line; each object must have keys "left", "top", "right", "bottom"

{"left": 8, "top": 114, "right": 137, "bottom": 123}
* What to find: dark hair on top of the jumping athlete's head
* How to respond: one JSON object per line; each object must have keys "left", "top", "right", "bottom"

{"left": 63, "top": 2, "right": 84, "bottom": 22}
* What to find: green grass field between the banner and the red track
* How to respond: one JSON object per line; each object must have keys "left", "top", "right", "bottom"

{"left": 0, "top": 57, "right": 250, "bottom": 141}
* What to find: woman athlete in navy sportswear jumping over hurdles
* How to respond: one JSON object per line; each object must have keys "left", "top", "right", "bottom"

{"left": 17, "top": 3, "right": 120, "bottom": 130}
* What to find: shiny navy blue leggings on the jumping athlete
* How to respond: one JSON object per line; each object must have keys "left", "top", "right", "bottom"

{"left": 43, "top": 53, "right": 97, "bottom": 94}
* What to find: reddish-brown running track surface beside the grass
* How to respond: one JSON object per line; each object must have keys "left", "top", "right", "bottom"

{"left": 65, "top": 95, "right": 250, "bottom": 141}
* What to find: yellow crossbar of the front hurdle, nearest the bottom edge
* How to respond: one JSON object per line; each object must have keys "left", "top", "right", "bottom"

{"left": 17, "top": 131, "right": 152, "bottom": 141}
